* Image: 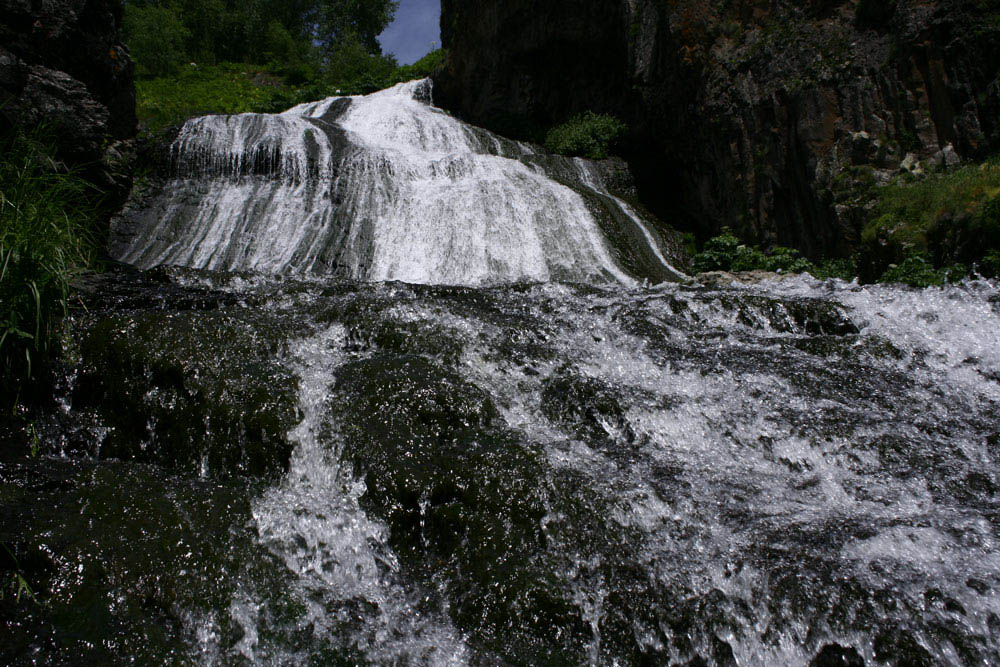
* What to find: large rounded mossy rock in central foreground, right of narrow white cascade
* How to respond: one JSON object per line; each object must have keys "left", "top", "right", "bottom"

{"left": 333, "top": 355, "right": 668, "bottom": 664}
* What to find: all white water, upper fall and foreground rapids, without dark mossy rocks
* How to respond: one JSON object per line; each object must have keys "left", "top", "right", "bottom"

{"left": 86, "top": 82, "right": 1000, "bottom": 665}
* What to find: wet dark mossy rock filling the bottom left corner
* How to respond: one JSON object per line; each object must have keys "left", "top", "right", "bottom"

{"left": 0, "top": 459, "right": 320, "bottom": 665}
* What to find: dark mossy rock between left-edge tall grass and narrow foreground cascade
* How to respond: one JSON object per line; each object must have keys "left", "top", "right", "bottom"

{"left": 72, "top": 310, "right": 298, "bottom": 478}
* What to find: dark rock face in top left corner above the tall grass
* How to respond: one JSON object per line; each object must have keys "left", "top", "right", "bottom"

{"left": 0, "top": 0, "right": 136, "bottom": 197}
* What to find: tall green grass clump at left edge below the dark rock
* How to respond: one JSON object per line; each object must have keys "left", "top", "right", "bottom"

{"left": 0, "top": 131, "right": 94, "bottom": 403}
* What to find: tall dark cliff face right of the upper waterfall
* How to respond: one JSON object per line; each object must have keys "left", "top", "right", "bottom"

{"left": 436, "top": 0, "right": 1000, "bottom": 257}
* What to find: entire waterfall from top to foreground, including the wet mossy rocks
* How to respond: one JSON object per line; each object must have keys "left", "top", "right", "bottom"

{"left": 0, "top": 82, "right": 1000, "bottom": 666}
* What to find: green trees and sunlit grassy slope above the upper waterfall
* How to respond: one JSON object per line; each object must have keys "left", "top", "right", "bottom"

{"left": 124, "top": 0, "right": 454, "bottom": 133}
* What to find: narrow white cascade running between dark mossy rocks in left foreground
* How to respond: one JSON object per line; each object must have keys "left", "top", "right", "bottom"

{"left": 248, "top": 325, "right": 468, "bottom": 667}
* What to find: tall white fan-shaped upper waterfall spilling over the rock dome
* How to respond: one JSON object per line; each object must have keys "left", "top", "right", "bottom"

{"left": 115, "top": 80, "right": 676, "bottom": 285}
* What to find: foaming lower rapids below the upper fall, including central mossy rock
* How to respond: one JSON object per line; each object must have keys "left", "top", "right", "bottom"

{"left": 25, "top": 268, "right": 1000, "bottom": 667}
